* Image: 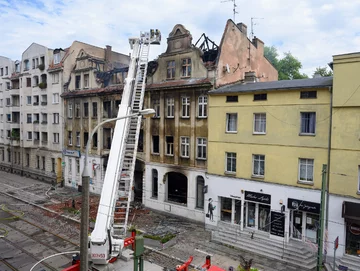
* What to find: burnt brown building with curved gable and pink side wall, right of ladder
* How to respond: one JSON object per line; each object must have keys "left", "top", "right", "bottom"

{"left": 143, "top": 20, "right": 277, "bottom": 221}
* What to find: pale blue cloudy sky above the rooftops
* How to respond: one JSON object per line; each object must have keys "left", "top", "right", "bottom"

{"left": 0, "top": 0, "right": 360, "bottom": 76}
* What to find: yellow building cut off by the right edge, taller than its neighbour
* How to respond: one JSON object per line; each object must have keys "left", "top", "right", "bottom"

{"left": 328, "top": 53, "right": 360, "bottom": 262}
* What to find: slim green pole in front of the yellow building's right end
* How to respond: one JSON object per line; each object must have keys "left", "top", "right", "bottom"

{"left": 316, "top": 164, "right": 327, "bottom": 271}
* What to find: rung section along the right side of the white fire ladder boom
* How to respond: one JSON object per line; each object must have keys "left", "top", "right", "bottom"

{"left": 113, "top": 43, "right": 150, "bottom": 237}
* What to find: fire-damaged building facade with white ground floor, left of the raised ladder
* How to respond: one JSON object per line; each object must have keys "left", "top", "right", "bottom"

{"left": 61, "top": 41, "right": 130, "bottom": 194}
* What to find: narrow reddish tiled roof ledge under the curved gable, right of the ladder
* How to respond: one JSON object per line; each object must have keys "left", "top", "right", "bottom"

{"left": 146, "top": 78, "right": 212, "bottom": 90}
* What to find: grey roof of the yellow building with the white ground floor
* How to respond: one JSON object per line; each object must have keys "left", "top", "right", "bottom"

{"left": 209, "top": 76, "right": 333, "bottom": 94}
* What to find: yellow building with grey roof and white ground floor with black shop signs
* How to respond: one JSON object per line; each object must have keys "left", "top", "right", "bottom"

{"left": 206, "top": 72, "right": 333, "bottom": 266}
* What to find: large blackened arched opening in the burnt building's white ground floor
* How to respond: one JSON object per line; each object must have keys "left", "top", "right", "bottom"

{"left": 166, "top": 172, "right": 188, "bottom": 204}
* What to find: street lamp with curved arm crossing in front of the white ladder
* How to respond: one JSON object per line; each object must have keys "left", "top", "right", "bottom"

{"left": 80, "top": 108, "right": 155, "bottom": 271}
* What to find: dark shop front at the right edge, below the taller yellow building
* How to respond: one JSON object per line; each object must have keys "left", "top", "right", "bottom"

{"left": 342, "top": 201, "right": 360, "bottom": 256}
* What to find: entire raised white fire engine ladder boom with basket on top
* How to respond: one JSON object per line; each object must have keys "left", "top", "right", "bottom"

{"left": 89, "top": 30, "right": 161, "bottom": 270}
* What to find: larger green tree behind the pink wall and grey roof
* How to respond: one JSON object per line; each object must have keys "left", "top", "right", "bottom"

{"left": 264, "top": 46, "right": 308, "bottom": 80}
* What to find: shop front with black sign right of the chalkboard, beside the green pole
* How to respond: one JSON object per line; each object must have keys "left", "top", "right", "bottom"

{"left": 287, "top": 198, "right": 320, "bottom": 244}
